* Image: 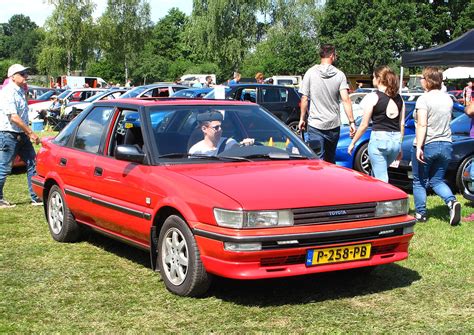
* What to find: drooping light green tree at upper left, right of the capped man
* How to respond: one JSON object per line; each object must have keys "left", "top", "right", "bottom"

{"left": 38, "top": 0, "right": 96, "bottom": 75}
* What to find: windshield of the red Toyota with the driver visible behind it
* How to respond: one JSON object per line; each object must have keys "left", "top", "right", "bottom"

{"left": 144, "top": 105, "right": 314, "bottom": 163}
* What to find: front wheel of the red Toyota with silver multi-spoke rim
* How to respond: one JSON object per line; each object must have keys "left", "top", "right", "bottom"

{"left": 157, "top": 215, "right": 212, "bottom": 297}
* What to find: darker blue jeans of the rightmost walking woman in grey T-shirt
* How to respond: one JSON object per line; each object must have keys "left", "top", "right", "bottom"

{"left": 411, "top": 141, "right": 456, "bottom": 214}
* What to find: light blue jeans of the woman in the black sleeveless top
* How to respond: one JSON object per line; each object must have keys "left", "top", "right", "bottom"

{"left": 369, "top": 130, "right": 401, "bottom": 183}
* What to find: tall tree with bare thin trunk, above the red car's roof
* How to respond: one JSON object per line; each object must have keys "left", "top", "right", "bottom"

{"left": 99, "top": 0, "right": 152, "bottom": 81}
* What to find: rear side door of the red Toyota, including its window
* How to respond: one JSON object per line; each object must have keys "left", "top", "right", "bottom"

{"left": 56, "top": 106, "right": 114, "bottom": 224}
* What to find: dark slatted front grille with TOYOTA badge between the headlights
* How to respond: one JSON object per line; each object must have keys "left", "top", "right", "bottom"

{"left": 292, "top": 202, "right": 376, "bottom": 225}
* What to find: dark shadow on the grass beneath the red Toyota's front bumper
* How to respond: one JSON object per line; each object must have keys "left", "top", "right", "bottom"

{"left": 209, "top": 263, "right": 421, "bottom": 307}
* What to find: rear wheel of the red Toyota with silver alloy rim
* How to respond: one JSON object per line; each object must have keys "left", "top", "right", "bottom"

{"left": 46, "top": 185, "right": 81, "bottom": 242}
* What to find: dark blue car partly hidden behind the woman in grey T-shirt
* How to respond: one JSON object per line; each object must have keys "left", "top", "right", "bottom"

{"left": 388, "top": 114, "right": 474, "bottom": 199}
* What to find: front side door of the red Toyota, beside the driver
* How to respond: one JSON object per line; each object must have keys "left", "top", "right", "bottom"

{"left": 91, "top": 109, "right": 152, "bottom": 246}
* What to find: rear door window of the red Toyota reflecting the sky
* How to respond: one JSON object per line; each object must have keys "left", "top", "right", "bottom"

{"left": 72, "top": 107, "right": 114, "bottom": 153}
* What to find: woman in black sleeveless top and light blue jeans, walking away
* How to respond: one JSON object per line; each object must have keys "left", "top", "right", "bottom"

{"left": 347, "top": 66, "right": 405, "bottom": 182}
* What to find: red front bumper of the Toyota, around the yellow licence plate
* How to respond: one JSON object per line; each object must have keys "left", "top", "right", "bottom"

{"left": 193, "top": 220, "right": 415, "bottom": 279}
